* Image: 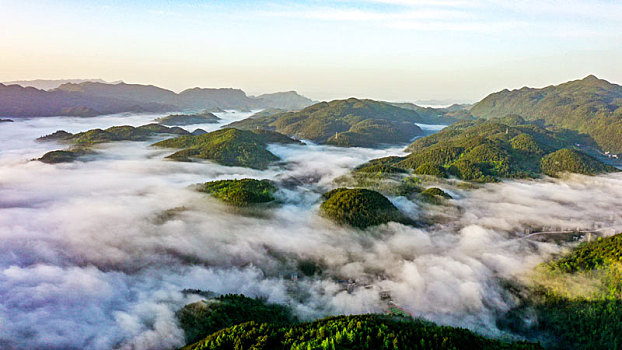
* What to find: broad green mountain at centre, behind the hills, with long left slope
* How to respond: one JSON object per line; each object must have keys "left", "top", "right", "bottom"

{"left": 229, "top": 98, "right": 423, "bottom": 147}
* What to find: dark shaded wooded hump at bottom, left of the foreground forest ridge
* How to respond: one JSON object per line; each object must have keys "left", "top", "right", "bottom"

{"left": 176, "top": 294, "right": 296, "bottom": 344}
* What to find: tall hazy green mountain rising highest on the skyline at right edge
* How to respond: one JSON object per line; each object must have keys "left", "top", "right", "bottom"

{"left": 470, "top": 75, "right": 622, "bottom": 153}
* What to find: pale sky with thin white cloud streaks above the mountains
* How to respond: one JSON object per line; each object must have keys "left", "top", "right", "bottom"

{"left": 0, "top": 0, "right": 622, "bottom": 102}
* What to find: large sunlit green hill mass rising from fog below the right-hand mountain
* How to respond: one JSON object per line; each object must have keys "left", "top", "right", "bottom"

{"left": 360, "top": 116, "right": 616, "bottom": 182}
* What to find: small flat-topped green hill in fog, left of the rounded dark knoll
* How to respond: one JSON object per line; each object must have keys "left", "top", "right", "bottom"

{"left": 198, "top": 179, "right": 276, "bottom": 207}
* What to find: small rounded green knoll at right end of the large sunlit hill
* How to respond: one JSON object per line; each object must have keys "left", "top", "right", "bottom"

{"left": 541, "top": 148, "right": 616, "bottom": 176}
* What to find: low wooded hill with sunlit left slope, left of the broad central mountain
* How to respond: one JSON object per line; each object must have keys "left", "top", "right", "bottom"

{"left": 154, "top": 128, "right": 299, "bottom": 169}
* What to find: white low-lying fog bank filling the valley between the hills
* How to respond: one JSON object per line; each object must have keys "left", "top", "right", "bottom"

{"left": 0, "top": 117, "right": 622, "bottom": 349}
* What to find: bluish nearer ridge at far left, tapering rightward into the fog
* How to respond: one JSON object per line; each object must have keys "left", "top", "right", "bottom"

{"left": 0, "top": 84, "right": 175, "bottom": 117}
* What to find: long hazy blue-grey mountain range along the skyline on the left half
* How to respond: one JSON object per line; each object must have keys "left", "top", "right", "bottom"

{"left": 0, "top": 81, "right": 314, "bottom": 117}
